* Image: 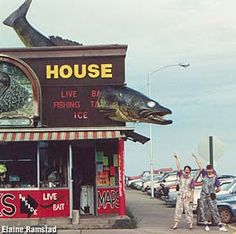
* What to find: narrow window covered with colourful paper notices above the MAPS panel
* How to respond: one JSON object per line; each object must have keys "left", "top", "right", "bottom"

{"left": 96, "top": 142, "right": 119, "bottom": 187}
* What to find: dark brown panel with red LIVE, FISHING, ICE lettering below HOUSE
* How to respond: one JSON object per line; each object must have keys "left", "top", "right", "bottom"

{"left": 42, "top": 86, "right": 124, "bottom": 127}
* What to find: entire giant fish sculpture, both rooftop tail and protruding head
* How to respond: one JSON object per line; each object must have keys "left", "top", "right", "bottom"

{"left": 3, "top": 0, "right": 172, "bottom": 125}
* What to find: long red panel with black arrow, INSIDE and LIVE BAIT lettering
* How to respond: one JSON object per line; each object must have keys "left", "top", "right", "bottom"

{"left": 0, "top": 189, "right": 70, "bottom": 218}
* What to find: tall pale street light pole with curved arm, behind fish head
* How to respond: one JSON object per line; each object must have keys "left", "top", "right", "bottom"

{"left": 147, "top": 63, "right": 190, "bottom": 198}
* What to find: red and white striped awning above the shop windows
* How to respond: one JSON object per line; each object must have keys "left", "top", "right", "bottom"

{"left": 0, "top": 130, "right": 122, "bottom": 142}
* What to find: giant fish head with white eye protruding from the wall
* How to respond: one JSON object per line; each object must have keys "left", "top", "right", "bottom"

{"left": 97, "top": 87, "right": 172, "bottom": 125}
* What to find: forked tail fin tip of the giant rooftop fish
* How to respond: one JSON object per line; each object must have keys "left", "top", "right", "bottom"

{"left": 3, "top": 0, "right": 32, "bottom": 27}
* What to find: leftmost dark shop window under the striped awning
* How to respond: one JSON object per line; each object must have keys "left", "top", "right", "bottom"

{"left": 0, "top": 142, "right": 37, "bottom": 188}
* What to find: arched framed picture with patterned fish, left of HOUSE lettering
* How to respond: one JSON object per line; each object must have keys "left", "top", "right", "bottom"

{"left": 0, "top": 54, "right": 41, "bottom": 128}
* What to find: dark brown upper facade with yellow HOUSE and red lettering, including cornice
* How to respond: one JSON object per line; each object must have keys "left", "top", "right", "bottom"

{"left": 0, "top": 45, "right": 127, "bottom": 127}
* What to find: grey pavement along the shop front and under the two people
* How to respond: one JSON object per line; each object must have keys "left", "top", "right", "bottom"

{"left": 58, "top": 189, "right": 234, "bottom": 234}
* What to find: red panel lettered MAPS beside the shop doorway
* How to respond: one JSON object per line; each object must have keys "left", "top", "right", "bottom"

{"left": 97, "top": 188, "right": 119, "bottom": 214}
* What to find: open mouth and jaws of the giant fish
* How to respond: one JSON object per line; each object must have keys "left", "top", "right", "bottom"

{"left": 139, "top": 109, "right": 173, "bottom": 125}
